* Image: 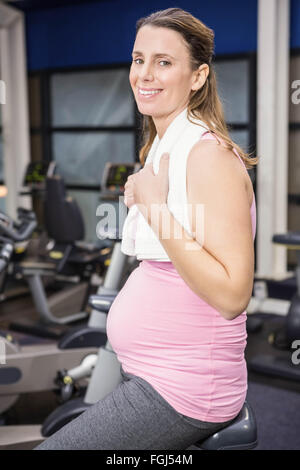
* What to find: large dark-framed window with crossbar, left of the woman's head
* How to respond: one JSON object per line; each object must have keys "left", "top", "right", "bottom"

{"left": 29, "top": 66, "right": 137, "bottom": 242}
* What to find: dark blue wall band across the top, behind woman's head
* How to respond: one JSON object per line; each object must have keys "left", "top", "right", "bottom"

{"left": 26, "top": 0, "right": 258, "bottom": 71}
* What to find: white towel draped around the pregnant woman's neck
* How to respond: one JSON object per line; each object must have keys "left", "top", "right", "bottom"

{"left": 121, "top": 108, "right": 208, "bottom": 261}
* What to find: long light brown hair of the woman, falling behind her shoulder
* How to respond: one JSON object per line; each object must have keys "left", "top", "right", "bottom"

{"left": 136, "top": 8, "right": 258, "bottom": 169}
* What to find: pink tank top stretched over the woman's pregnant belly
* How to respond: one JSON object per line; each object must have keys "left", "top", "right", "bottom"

{"left": 107, "top": 133, "right": 256, "bottom": 422}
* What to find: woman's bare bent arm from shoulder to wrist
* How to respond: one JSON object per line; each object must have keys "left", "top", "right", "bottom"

{"left": 148, "top": 142, "right": 254, "bottom": 320}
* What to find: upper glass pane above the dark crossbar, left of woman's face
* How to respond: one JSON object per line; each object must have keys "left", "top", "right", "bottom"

{"left": 51, "top": 69, "right": 134, "bottom": 127}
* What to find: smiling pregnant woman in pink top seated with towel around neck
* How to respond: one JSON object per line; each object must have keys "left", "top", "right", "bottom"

{"left": 39, "top": 8, "right": 256, "bottom": 450}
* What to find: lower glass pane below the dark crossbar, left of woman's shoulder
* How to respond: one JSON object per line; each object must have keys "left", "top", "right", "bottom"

{"left": 53, "top": 132, "right": 135, "bottom": 185}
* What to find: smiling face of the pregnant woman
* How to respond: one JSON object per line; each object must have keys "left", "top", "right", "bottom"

{"left": 129, "top": 25, "right": 203, "bottom": 118}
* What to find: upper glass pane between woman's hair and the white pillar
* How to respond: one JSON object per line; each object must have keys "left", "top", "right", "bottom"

{"left": 214, "top": 60, "right": 249, "bottom": 123}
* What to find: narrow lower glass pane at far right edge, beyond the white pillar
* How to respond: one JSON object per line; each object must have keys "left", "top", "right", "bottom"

{"left": 288, "top": 130, "right": 300, "bottom": 194}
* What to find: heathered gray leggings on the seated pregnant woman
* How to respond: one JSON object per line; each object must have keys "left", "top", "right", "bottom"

{"left": 36, "top": 368, "right": 236, "bottom": 450}
